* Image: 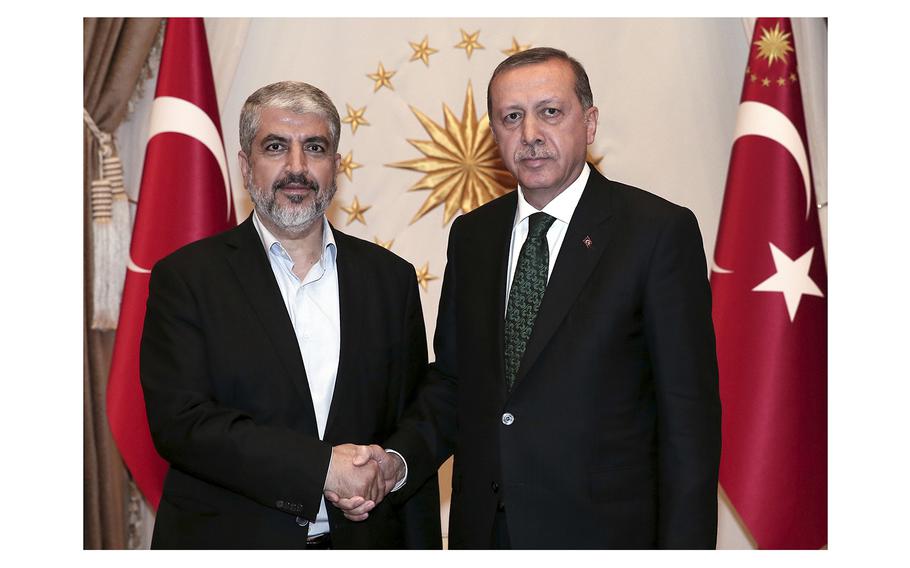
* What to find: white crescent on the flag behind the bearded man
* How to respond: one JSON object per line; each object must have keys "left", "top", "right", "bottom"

{"left": 148, "top": 97, "right": 231, "bottom": 220}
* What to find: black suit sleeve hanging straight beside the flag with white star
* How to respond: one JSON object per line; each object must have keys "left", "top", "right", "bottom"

{"left": 644, "top": 209, "right": 720, "bottom": 549}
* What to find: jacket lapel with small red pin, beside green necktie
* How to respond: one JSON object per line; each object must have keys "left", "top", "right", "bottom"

{"left": 516, "top": 166, "right": 611, "bottom": 390}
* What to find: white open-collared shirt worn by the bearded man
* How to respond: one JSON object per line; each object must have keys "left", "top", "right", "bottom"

{"left": 253, "top": 212, "right": 341, "bottom": 535}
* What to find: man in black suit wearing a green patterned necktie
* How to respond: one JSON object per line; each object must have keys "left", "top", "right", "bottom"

{"left": 333, "top": 48, "right": 720, "bottom": 549}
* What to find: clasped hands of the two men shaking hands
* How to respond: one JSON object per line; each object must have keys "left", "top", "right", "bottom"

{"left": 323, "top": 444, "right": 405, "bottom": 521}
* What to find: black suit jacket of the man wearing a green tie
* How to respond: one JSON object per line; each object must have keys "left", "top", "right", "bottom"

{"left": 386, "top": 167, "right": 720, "bottom": 549}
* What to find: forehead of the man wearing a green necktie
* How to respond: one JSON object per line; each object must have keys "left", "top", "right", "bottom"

{"left": 490, "top": 59, "right": 577, "bottom": 107}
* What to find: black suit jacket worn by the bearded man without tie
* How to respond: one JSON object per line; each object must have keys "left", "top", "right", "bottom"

{"left": 140, "top": 218, "right": 441, "bottom": 548}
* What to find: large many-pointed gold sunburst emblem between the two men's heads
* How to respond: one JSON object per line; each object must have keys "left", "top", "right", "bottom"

{"left": 386, "top": 82, "right": 516, "bottom": 226}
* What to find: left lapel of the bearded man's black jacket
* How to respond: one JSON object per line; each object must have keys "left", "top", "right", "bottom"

{"left": 227, "top": 215, "right": 316, "bottom": 424}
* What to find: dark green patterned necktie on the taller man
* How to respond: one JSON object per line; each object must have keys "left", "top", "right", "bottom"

{"left": 505, "top": 213, "right": 556, "bottom": 391}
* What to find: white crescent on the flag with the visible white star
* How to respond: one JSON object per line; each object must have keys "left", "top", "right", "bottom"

{"left": 733, "top": 101, "right": 812, "bottom": 219}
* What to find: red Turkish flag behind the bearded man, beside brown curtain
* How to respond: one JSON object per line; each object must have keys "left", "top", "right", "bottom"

{"left": 107, "top": 18, "right": 236, "bottom": 510}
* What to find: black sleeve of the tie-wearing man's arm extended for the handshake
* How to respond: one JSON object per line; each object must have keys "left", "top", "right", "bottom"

{"left": 386, "top": 218, "right": 460, "bottom": 497}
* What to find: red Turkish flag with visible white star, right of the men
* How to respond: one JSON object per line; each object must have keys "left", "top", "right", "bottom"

{"left": 711, "top": 18, "right": 828, "bottom": 549}
